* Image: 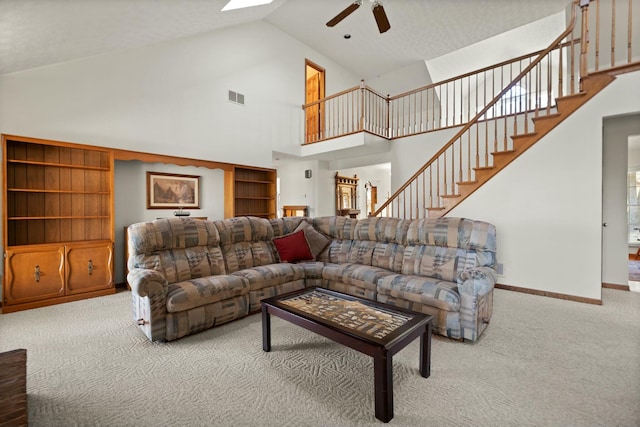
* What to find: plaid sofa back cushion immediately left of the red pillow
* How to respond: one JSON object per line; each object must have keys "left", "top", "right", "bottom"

{"left": 213, "top": 216, "right": 278, "bottom": 274}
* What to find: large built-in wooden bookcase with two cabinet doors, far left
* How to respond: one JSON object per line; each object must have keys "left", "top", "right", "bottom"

{"left": 2, "top": 135, "right": 115, "bottom": 312}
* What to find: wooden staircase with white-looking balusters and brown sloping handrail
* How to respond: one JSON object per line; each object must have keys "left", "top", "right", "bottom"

{"left": 372, "top": 0, "right": 640, "bottom": 219}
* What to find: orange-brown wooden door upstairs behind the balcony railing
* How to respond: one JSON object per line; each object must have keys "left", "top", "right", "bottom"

{"left": 305, "top": 60, "right": 325, "bottom": 143}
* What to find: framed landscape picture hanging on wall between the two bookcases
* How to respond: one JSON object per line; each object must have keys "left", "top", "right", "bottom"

{"left": 147, "top": 171, "right": 200, "bottom": 209}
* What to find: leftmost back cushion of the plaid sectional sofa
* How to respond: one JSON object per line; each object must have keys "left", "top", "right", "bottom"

{"left": 127, "top": 218, "right": 226, "bottom": 283}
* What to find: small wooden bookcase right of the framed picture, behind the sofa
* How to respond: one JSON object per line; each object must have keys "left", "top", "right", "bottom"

{"left": 233, "top": 166, "right": 277, "bottom": 219}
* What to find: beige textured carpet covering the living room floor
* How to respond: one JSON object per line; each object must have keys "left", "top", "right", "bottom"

{"left": 0, "top": 289, "right": 640, "bottom": 427}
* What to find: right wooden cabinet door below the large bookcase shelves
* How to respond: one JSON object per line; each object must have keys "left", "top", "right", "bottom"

{"left": 66, "top": 242, "right": 113, "bottom": 295}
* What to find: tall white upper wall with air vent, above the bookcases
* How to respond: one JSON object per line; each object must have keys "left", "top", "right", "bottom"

{"left": 0, "top": 22, "right": 359, "bottom": 167}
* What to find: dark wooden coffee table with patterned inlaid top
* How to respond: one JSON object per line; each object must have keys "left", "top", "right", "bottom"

{"left": 262, "top": 288, "right": 432, "bottom": 423}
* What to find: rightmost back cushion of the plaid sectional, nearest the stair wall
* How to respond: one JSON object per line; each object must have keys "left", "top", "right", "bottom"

{"left": 402, "top": 217, "right": 496, "bottom": 281}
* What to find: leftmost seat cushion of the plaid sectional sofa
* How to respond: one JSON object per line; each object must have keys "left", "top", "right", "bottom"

{"left": 167, "top": 275, "right": 249, "bottom": 313}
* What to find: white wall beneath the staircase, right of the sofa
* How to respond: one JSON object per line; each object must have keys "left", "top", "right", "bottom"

{"left": 450, "top": 72, "right": 640, "bottom": 300}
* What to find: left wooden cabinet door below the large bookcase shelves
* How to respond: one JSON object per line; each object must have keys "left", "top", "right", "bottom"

{"left": 4, "top": 246, "right": 64, "bottom": 305}
